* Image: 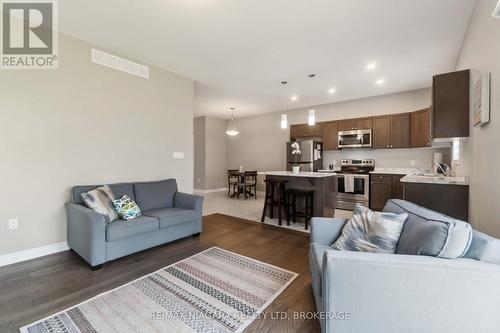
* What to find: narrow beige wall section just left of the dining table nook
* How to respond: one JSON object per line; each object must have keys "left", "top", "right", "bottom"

{"left": 194, "top": 117, "right": 227, "bottom": 190}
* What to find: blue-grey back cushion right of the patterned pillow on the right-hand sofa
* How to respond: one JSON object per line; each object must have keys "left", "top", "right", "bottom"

{"left": 384, "top": 199, "right": 472, "bottom": 259}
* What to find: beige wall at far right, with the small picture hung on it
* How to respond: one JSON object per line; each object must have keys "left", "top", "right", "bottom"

{"left": 457, "top": 0, "right": 500, "bottom": 237}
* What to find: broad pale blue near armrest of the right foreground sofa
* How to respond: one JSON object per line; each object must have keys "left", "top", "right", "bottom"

{"left": 322, "top": 250, "right": 500, "bottom": 333}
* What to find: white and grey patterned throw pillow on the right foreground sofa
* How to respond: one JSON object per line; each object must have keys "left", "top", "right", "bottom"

{"left": 332, "top": 205, "right": 408, "bottom": 253}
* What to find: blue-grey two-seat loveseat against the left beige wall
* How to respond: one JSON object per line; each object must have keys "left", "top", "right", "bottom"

{"left": 66, "top": 179, "right": 203, "bottom": 269}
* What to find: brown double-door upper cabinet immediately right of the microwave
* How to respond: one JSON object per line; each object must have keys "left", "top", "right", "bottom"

{"left": 373, "top": 113, "right": 410, "bottom": 149}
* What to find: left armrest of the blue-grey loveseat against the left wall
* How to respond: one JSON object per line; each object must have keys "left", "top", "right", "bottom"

{"left": 66, "top": 203, "right": 106, "bottom": 266}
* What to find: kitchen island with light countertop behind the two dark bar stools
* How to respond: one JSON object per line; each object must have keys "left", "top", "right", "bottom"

{"left": 259, "top": 171, "right": 336, "bottom": 217}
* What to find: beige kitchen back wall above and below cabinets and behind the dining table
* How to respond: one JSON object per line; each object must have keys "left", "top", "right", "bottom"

{"left": 227, "top": 89, "right": 449, "bottom": 171}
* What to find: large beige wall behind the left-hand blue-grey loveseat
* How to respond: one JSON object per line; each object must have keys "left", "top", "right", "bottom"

{"left": 0, "top": 36, "right": 193, "bottom": 255}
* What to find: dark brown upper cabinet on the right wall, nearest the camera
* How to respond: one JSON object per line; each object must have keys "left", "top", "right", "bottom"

{"left": 432, "top": 70, "right": 470, "bottom": 139}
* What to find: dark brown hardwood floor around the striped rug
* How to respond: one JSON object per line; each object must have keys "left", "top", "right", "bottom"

{"left": 0, "top": 214, "right": 320, "bottom": 333}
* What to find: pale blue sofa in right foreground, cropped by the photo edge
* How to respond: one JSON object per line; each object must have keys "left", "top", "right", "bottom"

{"left": 309, "top": 200, "right": 500, "bottom": 333}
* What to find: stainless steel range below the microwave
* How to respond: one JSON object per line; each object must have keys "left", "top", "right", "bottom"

{"left": 335, "top": 160, "right": 375, "bottom": 210}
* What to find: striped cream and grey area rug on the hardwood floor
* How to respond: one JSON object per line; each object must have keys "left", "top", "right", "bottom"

{"left": 20, "top": 247, "right": 298, "bottom": 333}
